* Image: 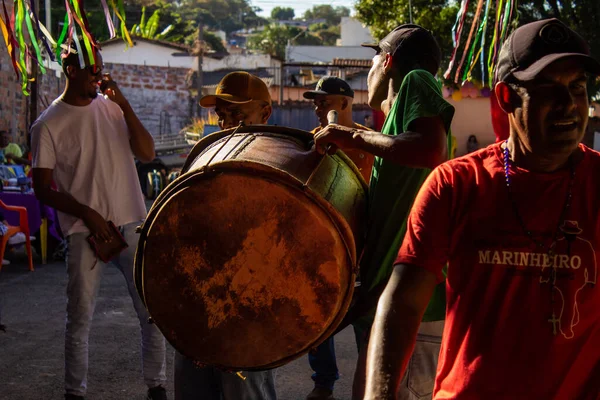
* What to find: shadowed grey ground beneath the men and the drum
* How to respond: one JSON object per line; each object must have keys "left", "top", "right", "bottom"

{"left": 0, "top": 254, "right": 356, "bottom": 400}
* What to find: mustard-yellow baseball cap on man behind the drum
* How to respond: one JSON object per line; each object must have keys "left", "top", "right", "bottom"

{"left": 200, "top": 71, "right": 271, "bottom": 108}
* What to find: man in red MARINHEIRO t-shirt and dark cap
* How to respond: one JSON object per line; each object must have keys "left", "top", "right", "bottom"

{"left": 365, "top": 19, "right": 600, "bottom": 400}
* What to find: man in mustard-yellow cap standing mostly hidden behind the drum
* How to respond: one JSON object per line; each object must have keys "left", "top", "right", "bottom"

{"left": 174, "top": 71, "right": 277, "bottom": 400}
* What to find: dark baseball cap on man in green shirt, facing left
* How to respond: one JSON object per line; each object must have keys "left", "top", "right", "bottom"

{"left": 361, "top": 24, "right": 442, "bottom": 70}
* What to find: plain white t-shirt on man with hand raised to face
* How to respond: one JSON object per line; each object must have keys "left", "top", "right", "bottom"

{"left": 31, "top": 95, "right": 146, "bottom": 235}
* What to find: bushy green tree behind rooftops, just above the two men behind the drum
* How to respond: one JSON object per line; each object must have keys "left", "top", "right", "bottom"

{"left": 247, "top": 24, "right": 322, "bottom": 60}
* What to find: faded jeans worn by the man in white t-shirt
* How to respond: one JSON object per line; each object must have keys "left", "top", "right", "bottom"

{"left": 65, "top": 223, "right": 167, "bottom": 396}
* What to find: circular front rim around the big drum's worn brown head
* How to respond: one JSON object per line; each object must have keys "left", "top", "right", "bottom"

{"left": 134, "top": 160, "right": 358, "bottom": 371}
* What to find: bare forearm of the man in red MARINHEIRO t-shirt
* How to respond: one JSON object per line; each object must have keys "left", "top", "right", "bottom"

{"left": 365, "top": 264, "right": 436, "bottom": 400}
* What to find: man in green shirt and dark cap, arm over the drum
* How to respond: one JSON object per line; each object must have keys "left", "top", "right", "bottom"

{"left": 315, "top": 24, "right": 454, "bottom": 399}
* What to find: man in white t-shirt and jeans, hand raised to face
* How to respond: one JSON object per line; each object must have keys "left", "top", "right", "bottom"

{"left": 31, "top": 48, "right": 167, "bottom": 400}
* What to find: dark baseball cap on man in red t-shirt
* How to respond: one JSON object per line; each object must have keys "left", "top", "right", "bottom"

{"left": 496, "top": 18, "right": 600, "bottom": 81}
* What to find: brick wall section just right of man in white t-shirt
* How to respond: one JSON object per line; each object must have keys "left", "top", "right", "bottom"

{"left": 104, "top": 63, "right": 193, "bottom": 136}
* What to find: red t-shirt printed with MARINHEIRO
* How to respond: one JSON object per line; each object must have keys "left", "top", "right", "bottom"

{"left": 397, "top": 144, "right": 600, "bottom": 400}
